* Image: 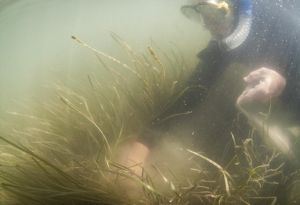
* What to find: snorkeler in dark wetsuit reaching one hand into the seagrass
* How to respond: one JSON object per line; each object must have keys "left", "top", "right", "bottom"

{"left": 123, "top": 0, "right": 300, "bottom": 202}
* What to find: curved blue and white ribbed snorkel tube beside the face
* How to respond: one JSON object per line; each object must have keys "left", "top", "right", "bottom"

{"left": 222, "top": 0, "right": 253, "bottom": 50}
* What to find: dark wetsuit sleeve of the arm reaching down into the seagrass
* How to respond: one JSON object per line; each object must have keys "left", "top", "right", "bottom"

{"left": 138, "top": 41, "right": 226, "bottom": 147}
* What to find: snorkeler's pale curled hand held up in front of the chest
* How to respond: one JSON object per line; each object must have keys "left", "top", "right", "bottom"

{"left": 237, "top": 67, "right": 286, "bottom": 105}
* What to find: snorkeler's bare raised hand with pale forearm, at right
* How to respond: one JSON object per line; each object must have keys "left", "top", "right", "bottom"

{"left": 237, "top": 67, "right": 293, "bottom": 158}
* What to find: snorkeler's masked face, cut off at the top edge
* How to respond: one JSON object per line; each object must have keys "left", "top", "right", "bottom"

{"left": 181, "top": 0, "right": 238, "bottom": 39}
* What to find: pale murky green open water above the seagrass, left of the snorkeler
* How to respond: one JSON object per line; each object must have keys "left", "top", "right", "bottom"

{"left": 0, "top": 0, "right": 207, "bottom": 112}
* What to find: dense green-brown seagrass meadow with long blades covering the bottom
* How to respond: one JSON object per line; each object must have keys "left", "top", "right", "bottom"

{"left": 0, "top": 33, "right": 283, "bottom": 205}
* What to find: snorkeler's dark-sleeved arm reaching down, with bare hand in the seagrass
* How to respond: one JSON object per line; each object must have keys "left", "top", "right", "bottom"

{"left": 122, "top": 41, "right": 226, "bottom": 174}
